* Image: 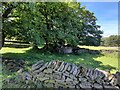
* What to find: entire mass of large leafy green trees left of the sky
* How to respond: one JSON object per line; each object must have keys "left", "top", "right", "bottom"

{"left": 2, "top": 2, "right": 103, "bottom": 50}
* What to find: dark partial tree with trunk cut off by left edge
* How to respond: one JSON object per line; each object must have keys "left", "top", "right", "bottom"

{"left": 2, "top": 2, "right": 17, "bottom": 46}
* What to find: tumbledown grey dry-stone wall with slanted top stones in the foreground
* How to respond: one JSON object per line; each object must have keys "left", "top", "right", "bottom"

{"left": 14, "top": 61, "right": 120, "bottom": 90}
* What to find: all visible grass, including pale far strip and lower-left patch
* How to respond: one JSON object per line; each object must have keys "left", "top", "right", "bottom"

{"left": 0, "top": 43, "right": 118, "bottom": 88}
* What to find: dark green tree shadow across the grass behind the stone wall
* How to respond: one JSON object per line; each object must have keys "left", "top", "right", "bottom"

{"left": 2, "top": 49, "right": 116, "bottom": 70}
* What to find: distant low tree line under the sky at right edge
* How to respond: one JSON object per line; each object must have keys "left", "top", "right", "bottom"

{"left": 102, "top": 35, "right": 120, "bottom": 46}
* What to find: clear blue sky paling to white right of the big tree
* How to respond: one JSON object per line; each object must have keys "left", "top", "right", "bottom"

{"left": 78, "top": 1, "right": 118, "bottom": 37}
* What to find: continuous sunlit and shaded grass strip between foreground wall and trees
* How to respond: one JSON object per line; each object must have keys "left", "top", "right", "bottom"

{"left": 0, "top": 47, "right": 118, "bottom": 73}
